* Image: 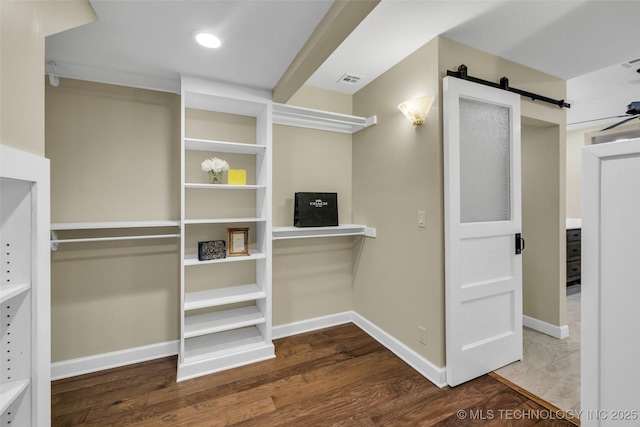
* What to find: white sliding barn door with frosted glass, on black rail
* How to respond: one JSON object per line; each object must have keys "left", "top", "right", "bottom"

{"left": 443, "top": 77, "right": 522, "bottom": 386}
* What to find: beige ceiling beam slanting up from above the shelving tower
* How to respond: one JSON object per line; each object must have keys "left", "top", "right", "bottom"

{"left": 272, "top": 0, "right": 380, "bottom": 103}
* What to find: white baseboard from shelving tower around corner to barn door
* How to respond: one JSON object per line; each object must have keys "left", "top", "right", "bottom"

{"left": 273, "top": 311, "right": 447, "bottom": 387}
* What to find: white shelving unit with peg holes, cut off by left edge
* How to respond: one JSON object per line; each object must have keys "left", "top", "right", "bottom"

{"left": 0, "top": 145, "right": 51, "bottom": 427}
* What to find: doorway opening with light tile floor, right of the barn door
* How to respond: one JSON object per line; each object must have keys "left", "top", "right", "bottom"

{"left": 495, "top": 118, "right": 581, "bottom": 413}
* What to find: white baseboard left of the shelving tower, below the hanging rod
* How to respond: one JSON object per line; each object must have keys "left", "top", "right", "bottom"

{"left": 51, "top": 341, "right": 179, "bottom": 380}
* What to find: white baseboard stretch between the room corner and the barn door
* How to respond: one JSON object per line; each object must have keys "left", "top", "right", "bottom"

{"left": 353, "top": 312, "right": 447, "bottom": 387}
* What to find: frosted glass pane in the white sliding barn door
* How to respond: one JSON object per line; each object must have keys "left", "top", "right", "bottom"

{"left": 460, "top": 98, "right": 511, "bottom": 223}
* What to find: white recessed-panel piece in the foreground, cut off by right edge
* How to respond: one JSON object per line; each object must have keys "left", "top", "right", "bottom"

{"left": 580, "top": 139, "right": 640, "bottom": 427}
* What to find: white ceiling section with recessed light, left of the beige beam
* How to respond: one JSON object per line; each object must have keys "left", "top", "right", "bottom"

{"left": 46, "top": 0, "right": 332, "bottom": 92}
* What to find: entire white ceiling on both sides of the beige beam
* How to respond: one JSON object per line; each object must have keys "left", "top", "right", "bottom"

{"left": 46, "top": 0, "right": 640, "bottom": 128}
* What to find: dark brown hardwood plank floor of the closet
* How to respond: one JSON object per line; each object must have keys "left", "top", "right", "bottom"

{"left": 51, "top": 324, "right": 572, "bottom": 427}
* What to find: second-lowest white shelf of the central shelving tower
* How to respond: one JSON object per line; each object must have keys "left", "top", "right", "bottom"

{"left": 184, "top": 306, "right": 266, "bottom": 338}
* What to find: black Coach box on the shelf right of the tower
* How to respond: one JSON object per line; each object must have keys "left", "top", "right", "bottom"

{"left": 293, "top": 193, "right": 338, "bottom": 227}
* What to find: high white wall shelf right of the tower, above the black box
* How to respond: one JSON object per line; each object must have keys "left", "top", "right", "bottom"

{"left": 273, "top": 103, "right": 378, "bottom": 134}
